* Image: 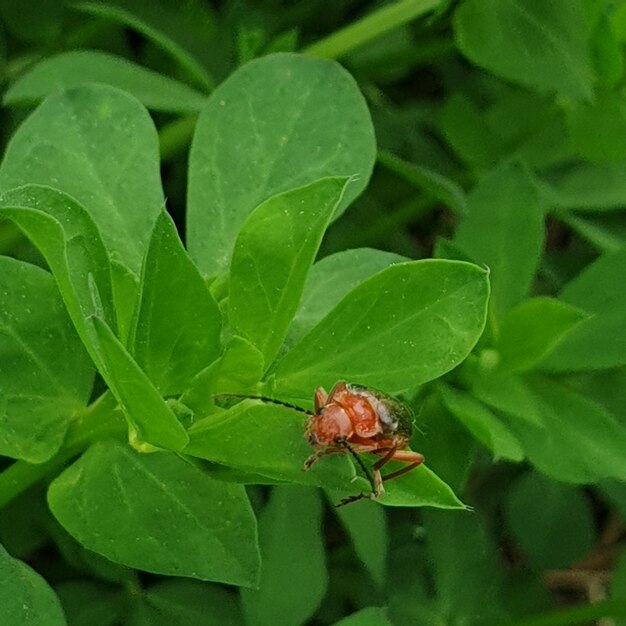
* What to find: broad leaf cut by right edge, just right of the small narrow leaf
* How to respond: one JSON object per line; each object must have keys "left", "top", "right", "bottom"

{"left": 510, "top": 379, "right": 626, "bottom": 484}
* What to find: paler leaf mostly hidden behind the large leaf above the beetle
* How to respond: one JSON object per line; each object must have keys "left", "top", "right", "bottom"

{"left": 286, "top": 248, "right": 408, "bottom": 345}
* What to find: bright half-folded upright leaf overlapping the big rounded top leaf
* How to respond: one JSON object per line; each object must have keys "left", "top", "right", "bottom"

{"left": 228, "top": 178, "right": 346, "bottom": 363}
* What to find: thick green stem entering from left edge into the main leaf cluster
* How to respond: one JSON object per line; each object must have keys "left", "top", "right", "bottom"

{"left": 0, "top": 392, "right": 127, "bottom": 508}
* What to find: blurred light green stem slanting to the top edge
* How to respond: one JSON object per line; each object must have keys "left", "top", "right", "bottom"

{"left": 304, "top": 0, "right": 441, "bottom": 59}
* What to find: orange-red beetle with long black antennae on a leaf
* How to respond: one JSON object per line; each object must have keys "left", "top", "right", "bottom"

{"left": 217, "top": 380, "right": 424, "bottom": 506}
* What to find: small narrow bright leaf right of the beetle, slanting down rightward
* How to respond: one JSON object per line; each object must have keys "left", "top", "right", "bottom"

{"left": 440, "top": 385, "right": 524, "bottom": 461}
